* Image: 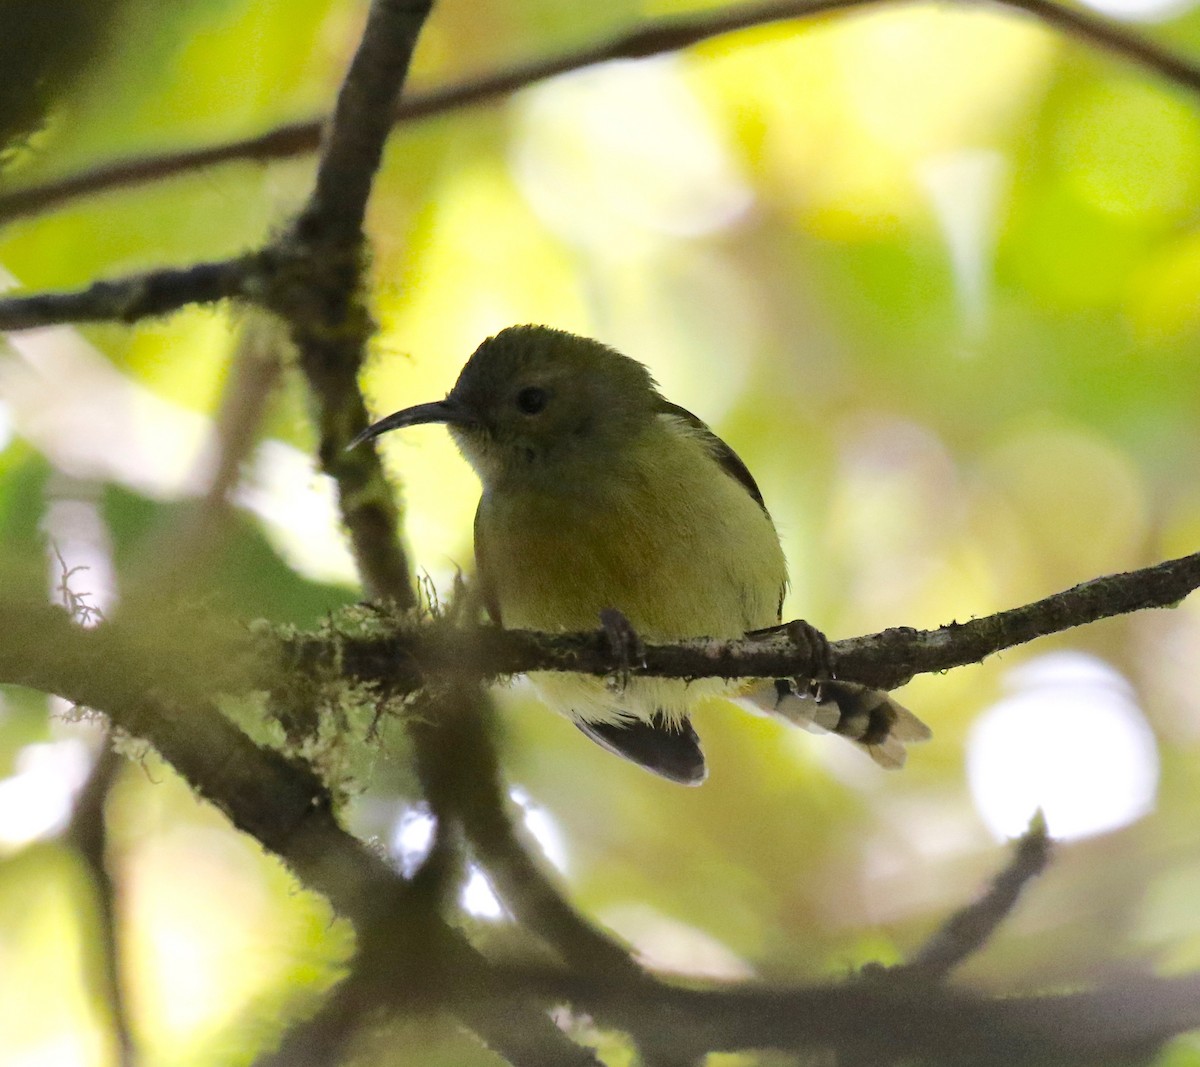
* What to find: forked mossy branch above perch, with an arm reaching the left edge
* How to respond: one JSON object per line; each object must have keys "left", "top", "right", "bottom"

{"left": 0, "top": 0, "right": 431, "bottom": 606}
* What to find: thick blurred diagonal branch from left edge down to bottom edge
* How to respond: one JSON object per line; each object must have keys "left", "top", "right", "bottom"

{"left": 0, "top": 601, "right": 604, "bottom": 1067}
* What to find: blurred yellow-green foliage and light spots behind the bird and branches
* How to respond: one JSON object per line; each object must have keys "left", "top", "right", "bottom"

{"left": 0, "top": 0, "right": 1200, "bottom": 1067}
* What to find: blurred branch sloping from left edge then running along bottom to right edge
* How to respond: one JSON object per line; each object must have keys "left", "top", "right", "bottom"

{"left": 0, "top": 603, "right": 1200, "bottom": 1065}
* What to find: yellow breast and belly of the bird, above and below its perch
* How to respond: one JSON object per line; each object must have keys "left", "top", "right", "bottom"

{"left": 476, "top": 424, "right": 787, "bottom": 721}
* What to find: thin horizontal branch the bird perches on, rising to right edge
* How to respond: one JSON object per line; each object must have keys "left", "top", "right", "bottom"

{"left": 302, "top": 552, "right": 1200, "bottom": 693}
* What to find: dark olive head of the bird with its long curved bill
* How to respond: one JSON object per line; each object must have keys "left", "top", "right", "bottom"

{"left": 352, "top": 326, "right": 660, "bottom": 485}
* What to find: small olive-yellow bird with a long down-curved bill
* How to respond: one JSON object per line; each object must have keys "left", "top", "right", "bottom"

{"left": 349, "top": 325, "right": 930, "bottom": 785}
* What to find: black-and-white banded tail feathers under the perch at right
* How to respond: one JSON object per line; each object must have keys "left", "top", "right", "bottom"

{"left": 743, "top": 678, "right": 932, "bottom": 771}
